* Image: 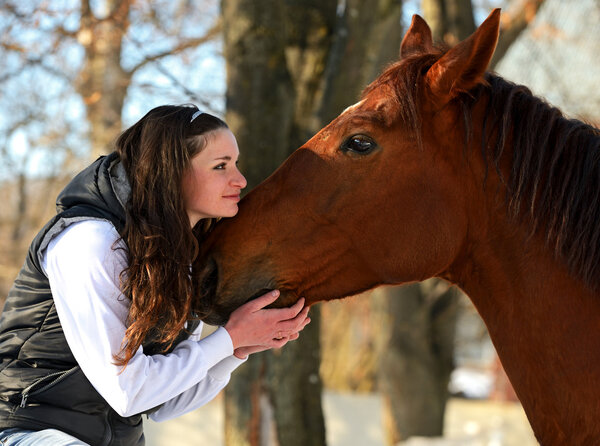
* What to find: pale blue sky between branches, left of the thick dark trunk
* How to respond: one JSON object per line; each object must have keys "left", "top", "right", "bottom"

{"left": 0, "top": 0, "right": 225, "bottom": 181}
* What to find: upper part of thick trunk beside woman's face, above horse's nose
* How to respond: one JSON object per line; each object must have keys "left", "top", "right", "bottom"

{"left": 221, "top": 0, "right": 295, "bottom": 189}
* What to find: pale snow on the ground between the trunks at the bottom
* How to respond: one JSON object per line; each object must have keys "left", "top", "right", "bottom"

{"left": 144, "top": 392, "right": 538, "bottom": 446}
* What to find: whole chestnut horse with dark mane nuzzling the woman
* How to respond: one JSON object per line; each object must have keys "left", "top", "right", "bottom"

{"left": 195, "top": 10, "right": 600, "bottom": 446}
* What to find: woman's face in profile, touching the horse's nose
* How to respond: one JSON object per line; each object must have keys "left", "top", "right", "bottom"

{"left": 182, "top": 129, "right": 247, "bottom": 227}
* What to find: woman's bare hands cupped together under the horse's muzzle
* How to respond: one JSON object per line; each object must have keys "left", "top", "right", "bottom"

{"left": 225, "top": 290, "right": 310, "bottom": 358}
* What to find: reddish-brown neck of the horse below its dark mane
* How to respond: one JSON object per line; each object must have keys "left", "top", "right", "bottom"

{"left": 447, "top": 191, "right": 600, "bottom": 445}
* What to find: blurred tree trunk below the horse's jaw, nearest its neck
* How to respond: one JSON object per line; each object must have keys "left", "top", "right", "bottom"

{"left": 373, "top": 279, "right": 458, "bottom": 445}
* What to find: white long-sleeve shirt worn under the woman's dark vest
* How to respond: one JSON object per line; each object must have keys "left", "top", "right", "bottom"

{"left": 42, "top": 220, "right": 243, "bottom": 421}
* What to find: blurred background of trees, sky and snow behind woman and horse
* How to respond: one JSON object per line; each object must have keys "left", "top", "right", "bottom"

{"left": 0, "top": 0, "right": 600, "bottom": 446}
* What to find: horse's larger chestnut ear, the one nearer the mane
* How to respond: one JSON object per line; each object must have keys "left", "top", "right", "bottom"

{"left": 426, "top": 8, "right": 500, "bottom": 103}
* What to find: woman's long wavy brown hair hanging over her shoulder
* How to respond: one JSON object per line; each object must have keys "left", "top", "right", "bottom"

{"left": 115, "top": 105, "right": 227, "bottom": 366}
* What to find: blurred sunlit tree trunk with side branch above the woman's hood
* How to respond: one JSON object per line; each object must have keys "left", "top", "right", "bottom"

{"left": 75, "top": 0, "right": 220, "bottom": 157}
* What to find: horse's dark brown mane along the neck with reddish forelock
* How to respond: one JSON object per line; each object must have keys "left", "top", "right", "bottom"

{"left": 363, "top": 50, "right": 600, "bottom": 290}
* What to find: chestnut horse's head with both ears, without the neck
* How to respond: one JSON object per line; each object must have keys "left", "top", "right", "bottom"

{"left": 198, "top": 10, "right": 500, "bottom": 324}
